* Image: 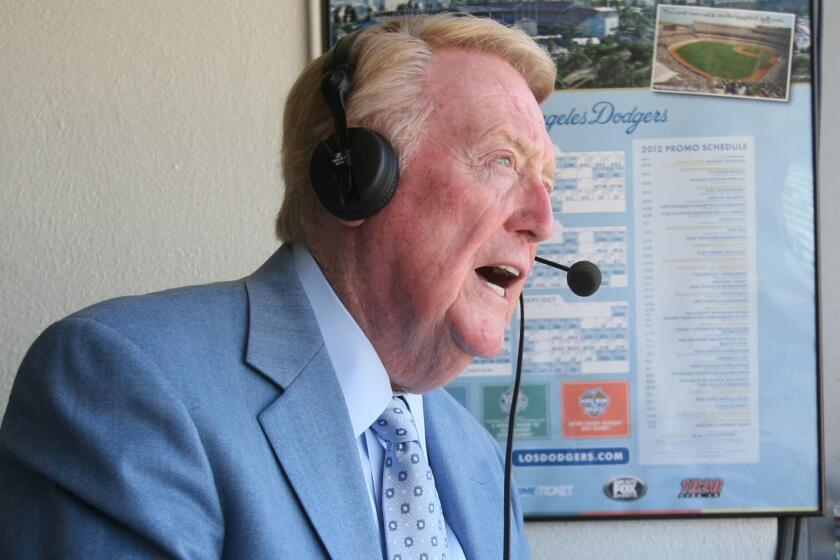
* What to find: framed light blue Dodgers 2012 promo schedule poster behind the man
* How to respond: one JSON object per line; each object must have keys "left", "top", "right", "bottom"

{"left": 330, "top": 0, "right": 821, "bottom": 518}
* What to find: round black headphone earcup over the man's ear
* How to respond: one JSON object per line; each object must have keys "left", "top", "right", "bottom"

{"left": 309, "top": 128, "right": 399, "bottom": 221}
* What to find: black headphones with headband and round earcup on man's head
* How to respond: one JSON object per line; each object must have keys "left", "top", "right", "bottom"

{"left": 309, "top": 33, "right": 399, "bottom": 220}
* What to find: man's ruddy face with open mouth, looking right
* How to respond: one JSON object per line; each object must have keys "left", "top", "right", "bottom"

{"left": 352, "top": 50, "right": 554, "bottom": 392}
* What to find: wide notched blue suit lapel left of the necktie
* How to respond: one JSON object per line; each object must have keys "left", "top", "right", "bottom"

{"left": 246, "top": 247, "right": 382, "bottom": 559}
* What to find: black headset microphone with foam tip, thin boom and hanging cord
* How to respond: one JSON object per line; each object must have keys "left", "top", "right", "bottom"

{"left": 502, "top": 256, "right": 601, "bottom": 560}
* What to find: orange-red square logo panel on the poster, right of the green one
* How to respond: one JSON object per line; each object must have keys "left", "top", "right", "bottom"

{"left": 560, "top": 381, "right": 630, "bottom": 438}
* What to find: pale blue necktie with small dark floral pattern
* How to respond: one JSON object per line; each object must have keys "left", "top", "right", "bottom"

{"left": 371, "top": 397, "right": 447, "bottom": 560}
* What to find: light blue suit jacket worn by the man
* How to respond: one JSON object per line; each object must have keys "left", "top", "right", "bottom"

{"left": 0, "top": 247, "right": 529, "bottom": 560}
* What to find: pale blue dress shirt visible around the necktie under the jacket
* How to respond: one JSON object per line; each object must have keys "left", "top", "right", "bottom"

{"left": 292, "top": 244, "right": 465, "bottom": 560}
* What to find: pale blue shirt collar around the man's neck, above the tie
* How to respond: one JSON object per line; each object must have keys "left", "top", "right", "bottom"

{"left": 292, "top": 244, "right": 396, "bottom": 437}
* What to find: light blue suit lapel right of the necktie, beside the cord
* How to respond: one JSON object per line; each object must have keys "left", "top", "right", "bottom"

{"left": 423, "top": 389, "right": 503, "bottom": 560}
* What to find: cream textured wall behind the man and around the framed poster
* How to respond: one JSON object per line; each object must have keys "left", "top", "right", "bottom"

{"left": 0, "top": 0, "right": 840, "bottom": 560}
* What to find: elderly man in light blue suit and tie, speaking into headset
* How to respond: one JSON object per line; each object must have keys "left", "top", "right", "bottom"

{"left": 0, "top": 16, "right": 554, "bottom": 560}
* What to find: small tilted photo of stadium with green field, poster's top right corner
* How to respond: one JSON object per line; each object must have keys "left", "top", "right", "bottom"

{"left": 651, "top": 5, "right": 796, "bottom": 101}
